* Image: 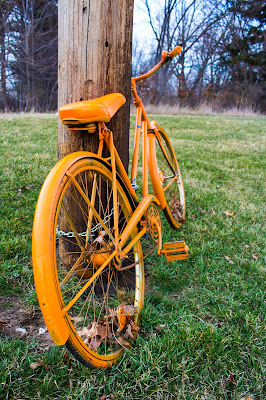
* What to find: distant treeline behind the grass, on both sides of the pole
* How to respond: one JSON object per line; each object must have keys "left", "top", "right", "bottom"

{"left": 0, "top": 0, "right": 266, "bottom": 112}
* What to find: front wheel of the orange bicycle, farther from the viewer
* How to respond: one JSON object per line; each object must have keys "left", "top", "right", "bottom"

{"left": 148, "top": 127, "right": 186, "bottom": 228}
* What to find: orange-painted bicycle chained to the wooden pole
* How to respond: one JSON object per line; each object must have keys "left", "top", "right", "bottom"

{"left": 32, "top": 46, "right": 188, "bottom": 368}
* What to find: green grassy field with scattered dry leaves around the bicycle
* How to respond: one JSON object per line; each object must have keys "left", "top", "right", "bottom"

{"left": 0, "top": 115, "right": 266, "bottom": 400}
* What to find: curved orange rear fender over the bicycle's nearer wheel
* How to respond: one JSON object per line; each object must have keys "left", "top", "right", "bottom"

{"left": 32, "top": 151, "right": 108, "bottom": 345}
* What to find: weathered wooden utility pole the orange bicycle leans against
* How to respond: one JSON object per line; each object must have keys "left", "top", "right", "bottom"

{"left": 58, "top": 0, "right": 134, "bottom": 168}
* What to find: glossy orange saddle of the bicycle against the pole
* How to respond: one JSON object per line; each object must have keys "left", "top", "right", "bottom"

{"left": 59, "top": 93, "right": 126, "bottom": 125}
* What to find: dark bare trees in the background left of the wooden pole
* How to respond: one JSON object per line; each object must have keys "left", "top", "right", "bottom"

{"left": 0, "top": 0, "right": 58, "bottom": 111}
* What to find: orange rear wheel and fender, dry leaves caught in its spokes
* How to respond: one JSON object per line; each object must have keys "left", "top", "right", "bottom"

{"left": 33, "top": 156, "right": 144, "bottom": 368}
